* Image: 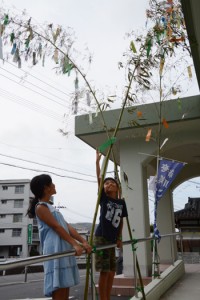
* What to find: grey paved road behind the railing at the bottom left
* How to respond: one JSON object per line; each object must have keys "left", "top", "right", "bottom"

{"left": 0, "top": 270, "right": 130, "bottom": 300}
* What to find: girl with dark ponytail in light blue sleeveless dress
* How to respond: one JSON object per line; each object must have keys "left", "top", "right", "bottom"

{"left": 27, "top": 174, "right": 92, "bottom": 300}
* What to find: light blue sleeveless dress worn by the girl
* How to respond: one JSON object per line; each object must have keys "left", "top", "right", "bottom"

{"left": 36, "top": 202, "right": 80, "bottom": 297}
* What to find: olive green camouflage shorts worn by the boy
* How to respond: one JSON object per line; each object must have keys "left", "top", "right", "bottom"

{"left": 94, "top": 236, "right": 116, "bottom": 272}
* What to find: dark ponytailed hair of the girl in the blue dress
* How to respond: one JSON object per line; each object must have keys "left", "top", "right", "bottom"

{"left": 27, "top": 174, "right": 52, "bottom": 218}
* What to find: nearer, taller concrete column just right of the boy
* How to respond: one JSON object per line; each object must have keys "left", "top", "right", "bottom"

{"left": 120, "top": 139, "right": 152, "bottom": 276}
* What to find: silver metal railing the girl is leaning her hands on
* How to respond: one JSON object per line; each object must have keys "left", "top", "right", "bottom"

{"left": 0, "top": 233, "right": 183, "bottom": 299}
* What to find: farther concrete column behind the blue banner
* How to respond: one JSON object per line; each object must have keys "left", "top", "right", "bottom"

{"left": 157, "top": 189, "right": 177, "bottom": 264}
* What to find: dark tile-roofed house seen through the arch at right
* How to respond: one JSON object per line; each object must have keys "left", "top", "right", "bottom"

{"left": 174, "top": 197, "right": 200, "bottom": 252}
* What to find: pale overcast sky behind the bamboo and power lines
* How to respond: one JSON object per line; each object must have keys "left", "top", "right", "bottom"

{"left": 0, "top": 0, "right": 200, "bottom": 222}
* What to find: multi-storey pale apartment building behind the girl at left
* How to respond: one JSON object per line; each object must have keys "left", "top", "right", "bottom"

{"left": 0, "top": 179, "right": 39, "bottom": 258}
